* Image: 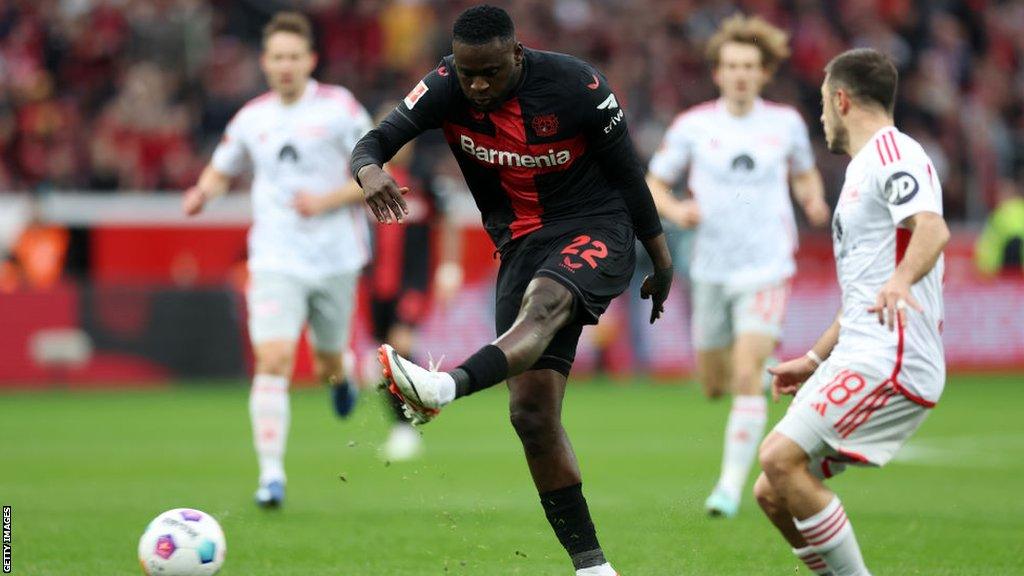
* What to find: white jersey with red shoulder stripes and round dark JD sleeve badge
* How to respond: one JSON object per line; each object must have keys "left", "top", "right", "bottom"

{"left": 831, "top": 126, "right": 945, "bottom": 404}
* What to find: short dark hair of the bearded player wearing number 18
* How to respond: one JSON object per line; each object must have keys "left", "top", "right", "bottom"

{"left": 825, "top": 48, "right": 899, "bottom": 114}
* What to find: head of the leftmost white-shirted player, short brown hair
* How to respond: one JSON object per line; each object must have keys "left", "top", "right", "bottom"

{"left": 260, "top": 12, "right": 316, "bottom": 100}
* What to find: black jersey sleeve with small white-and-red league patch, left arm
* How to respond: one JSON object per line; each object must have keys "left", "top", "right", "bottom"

{"left": 349, "top": 60, "right": 452, "bottom": 179}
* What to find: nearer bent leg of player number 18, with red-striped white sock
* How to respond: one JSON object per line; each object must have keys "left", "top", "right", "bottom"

{"left": 761, "top": 431, "right": 869, "bottom": 576}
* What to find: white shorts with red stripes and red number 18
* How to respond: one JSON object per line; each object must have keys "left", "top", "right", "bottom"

{"left": 775, "top": 359, "right": 930, "bottom": 479}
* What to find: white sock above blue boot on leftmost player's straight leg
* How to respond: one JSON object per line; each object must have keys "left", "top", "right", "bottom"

{"left": 249, "top": 374, "right": 292, "bottom": 485}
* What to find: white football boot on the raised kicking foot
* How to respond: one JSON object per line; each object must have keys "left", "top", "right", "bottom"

{"left": 377, "top": 344, "right": 455, "bottom": 425}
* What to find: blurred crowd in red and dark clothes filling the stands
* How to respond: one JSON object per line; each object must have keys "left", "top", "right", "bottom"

{"left": 0, "top": 0, "right": 1024, "bottom": 220}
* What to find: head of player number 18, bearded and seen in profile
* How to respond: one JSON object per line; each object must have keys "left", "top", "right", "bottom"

{"left": 821, "top": 48, "right": 899, "bottom": 154}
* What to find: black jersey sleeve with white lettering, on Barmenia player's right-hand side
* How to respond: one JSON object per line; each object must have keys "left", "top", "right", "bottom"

{"left": 574, "top": 66, "right": 662, "bottom": 240}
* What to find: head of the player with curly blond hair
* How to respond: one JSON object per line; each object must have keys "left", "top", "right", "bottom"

{"left": 708, "top": 14, "right": 790, "bottom": 104}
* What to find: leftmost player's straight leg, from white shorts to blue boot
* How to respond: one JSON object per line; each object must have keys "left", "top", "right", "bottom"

{"left": 247, "top": 273, "right": 306, "bottom": 507}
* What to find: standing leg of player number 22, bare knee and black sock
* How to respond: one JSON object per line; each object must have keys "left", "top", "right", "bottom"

{"left": 508, "top": 369, "right": 614, "bottom": 574}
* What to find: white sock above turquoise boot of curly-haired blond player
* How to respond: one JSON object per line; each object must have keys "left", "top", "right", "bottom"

{"left": 718, "top": 395, "right": 768, "bottom": 501}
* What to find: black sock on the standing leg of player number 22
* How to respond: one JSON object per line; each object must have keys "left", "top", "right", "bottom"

{"left": 541, "top": 484, "right": 607, "bottom": 570}
